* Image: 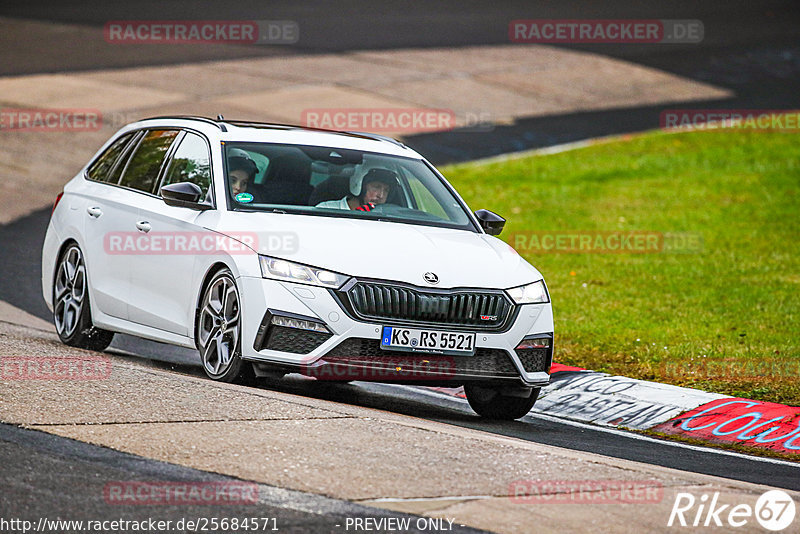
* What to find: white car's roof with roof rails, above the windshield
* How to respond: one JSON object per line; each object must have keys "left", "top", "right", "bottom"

{"left": 123, "top": 116, "right": 422, "bottom": 159}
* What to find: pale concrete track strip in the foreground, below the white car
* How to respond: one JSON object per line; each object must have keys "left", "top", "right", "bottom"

{"left": 0, "top": 323, "right": 796, "bottom": 532}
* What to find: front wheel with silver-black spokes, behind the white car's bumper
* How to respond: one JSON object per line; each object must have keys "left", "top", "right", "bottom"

{"left": 195, "top": 269, "right": 255, "bottom": 385}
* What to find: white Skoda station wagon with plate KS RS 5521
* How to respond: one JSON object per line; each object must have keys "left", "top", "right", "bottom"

{"left": 42, "top": 117, "right": 553, "bottom": 419}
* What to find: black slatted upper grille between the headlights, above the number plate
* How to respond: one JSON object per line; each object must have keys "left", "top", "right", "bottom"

{"left": 341, "top": 281, "right": 514, "bottom": 331}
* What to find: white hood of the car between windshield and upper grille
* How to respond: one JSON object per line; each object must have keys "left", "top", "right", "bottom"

{"left": 212, "top": 212, "right": 542, "bottom": 289}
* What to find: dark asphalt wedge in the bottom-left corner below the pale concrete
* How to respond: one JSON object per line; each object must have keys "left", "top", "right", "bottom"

{"left": 0, "top": 424, "right": 484, "bottom": 533}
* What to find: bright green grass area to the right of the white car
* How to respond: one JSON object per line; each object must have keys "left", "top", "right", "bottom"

{"left": 444, "top": 124, "right": 800, "bottom": 406}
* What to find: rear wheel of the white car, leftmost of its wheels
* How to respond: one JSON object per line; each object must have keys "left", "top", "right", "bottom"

{"left": 53, "top": 243, "right": 114, "bottom": 351}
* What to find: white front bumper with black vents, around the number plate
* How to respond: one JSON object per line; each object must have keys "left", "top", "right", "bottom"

{"left": 234, "top": 277, "right": 553, "bottom": 387}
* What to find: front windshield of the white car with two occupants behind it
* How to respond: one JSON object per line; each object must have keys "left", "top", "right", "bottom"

{"left": 225, "top": 143, "right": 475, "bottom": 231}
